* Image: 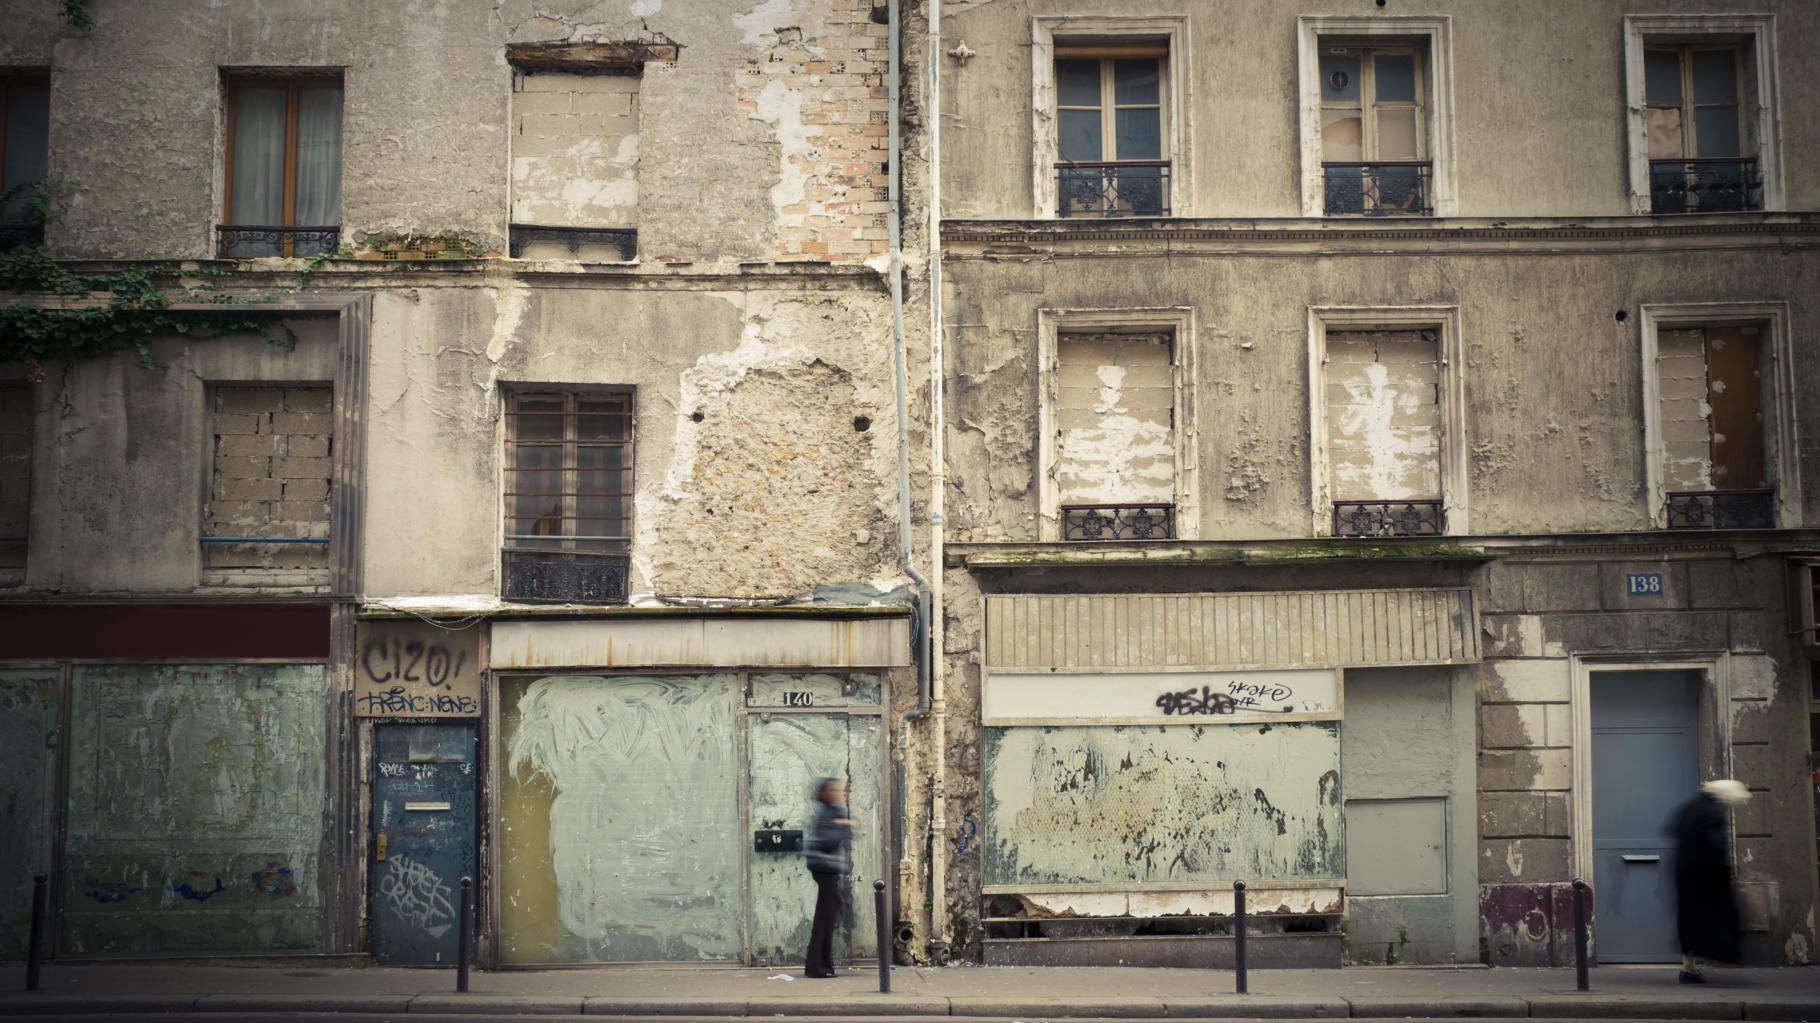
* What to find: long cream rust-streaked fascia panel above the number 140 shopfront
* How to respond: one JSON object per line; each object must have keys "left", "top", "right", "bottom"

{"left": 490, "top": 617, "right": 910, "bottom": 670}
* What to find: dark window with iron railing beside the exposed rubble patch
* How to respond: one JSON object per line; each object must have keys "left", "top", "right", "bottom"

{"left": 504, "top": 390, "right": 633, "bottom": 604}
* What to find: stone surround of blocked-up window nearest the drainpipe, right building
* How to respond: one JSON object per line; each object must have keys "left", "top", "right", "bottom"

{"left": 1036, "top": 306, "right": 1201, "bottom": 542}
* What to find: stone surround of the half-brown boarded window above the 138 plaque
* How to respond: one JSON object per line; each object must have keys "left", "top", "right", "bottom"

{"left": 1638, "top": 302, "right": 1802, "bottom": 530}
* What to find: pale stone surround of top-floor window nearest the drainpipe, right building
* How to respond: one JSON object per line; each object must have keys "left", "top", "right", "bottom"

{"left": 1030, "top": 15, "right": 1194, "bottom": 220}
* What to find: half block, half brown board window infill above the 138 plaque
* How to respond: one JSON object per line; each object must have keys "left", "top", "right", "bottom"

{"left": 1656, "top": 326, "right": 1771, "bottom": 491}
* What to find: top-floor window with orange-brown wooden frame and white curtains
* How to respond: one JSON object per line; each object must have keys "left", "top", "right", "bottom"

{"left": 220, "top": 75, "right": 342, "bottom": 257}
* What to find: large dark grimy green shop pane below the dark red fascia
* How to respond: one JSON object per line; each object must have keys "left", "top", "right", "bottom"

{"left": 58, "top": 664, "right": 328, "bottom": 954}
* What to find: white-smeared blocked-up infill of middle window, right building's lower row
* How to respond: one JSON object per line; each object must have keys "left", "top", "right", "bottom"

{"left": 1327, "top": 329, "right": 1441, "bottom": 501}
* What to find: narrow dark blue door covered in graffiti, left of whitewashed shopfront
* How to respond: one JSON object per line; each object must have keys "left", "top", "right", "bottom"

{"left": 368, "top": 724, "right": 477, "bottom": 967}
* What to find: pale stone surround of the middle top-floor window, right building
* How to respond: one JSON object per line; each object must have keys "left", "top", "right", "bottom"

{"left": 1296, "top": 15, "right": 1456, "bottom": 217}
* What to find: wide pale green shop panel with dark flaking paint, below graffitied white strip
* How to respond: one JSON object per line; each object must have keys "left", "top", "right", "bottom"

{"left": 981, "top": 723, "right": 1345, "bottom": 890}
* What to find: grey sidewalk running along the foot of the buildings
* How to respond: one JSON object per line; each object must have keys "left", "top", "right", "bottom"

{"left": 0, "top": 959, "right": 1820, "bottom": 1023}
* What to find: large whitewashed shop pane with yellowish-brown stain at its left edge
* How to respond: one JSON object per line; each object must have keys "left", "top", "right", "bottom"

{"left": 497, "top": 675, "right": 743, "bottom": 965}
